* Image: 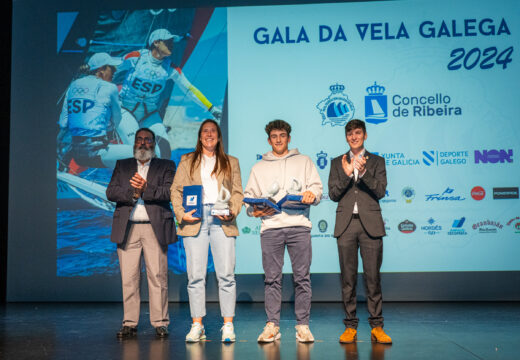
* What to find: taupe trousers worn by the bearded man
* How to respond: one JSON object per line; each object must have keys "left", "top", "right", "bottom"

{"left": 117, "top": 224, "right": 170, "bottom": 327}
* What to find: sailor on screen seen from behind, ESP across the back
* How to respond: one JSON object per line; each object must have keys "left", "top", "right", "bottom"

{"left": 58, "top": 53, "right": 133, "bottom": 168}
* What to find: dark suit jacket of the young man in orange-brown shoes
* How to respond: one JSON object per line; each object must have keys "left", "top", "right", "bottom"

{"left": 329, "top": 151, "right": 386, "bottom": 238}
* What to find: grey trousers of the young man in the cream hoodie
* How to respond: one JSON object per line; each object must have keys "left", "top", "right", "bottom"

{"left": 260, "top": 226, "right": 312, "bottom": 326}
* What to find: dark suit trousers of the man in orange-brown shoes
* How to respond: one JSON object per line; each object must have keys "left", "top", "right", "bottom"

{"left": 338, "top": 219, "right": 383, "bottom": 329}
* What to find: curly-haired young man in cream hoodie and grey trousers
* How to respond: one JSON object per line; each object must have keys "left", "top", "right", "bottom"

{"left": 244, "top": 120, "right": 323, "bottom": 342}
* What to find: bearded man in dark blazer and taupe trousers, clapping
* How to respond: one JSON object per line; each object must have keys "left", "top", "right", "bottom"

{"left": 106, "top": 128, "right": 177, "bottom": 338}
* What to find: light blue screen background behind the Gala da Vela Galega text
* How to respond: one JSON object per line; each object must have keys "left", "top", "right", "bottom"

{"left": 228, "top": 1, "right": 520, "bottom": 273}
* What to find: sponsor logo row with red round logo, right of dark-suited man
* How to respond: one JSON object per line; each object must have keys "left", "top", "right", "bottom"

{"left": 381, "top": 186, "right": 519, "bottom": 204}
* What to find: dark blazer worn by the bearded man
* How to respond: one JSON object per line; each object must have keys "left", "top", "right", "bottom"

{"left": 107, "top": 158, "right": 177, "bottom": 245}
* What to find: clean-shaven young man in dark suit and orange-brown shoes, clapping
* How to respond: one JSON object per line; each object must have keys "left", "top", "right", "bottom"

{"left": 329, "top": 119, "right": 392, "bottom": 344}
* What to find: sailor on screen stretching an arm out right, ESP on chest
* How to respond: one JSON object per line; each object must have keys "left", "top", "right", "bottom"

{"left": 115, "top": 29, "right": 221, "bottom": 159}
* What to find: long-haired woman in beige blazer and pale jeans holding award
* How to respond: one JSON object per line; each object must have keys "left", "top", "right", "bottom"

{"left": 171, "top": 119, "right": 244, "bottom": 342}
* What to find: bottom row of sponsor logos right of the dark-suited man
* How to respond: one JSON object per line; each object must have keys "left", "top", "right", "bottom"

{"left": 394, "top": 216, "right": 520, "bottom": 235}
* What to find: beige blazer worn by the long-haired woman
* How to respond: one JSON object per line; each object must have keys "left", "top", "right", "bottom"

{"left": 170, "top": 153, "right": 244, "bottom": 236}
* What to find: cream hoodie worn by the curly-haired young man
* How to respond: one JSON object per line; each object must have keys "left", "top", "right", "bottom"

{"left": 244, "top": 149, "right": 323, "bottom": 233}
